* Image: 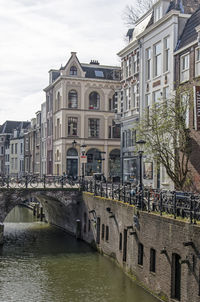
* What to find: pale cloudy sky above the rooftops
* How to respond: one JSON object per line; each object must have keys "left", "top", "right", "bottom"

{"left": 0, "top": 0, "right": 133, "bottom": 125}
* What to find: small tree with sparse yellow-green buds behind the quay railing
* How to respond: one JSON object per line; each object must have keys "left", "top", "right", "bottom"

{"left": 138, "top": 88, "right": 192, "bottom": 190}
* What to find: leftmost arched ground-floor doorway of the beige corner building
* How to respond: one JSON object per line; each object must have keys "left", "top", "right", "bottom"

{"left": 66, "top": 148, "right": 78, "bottom": 178}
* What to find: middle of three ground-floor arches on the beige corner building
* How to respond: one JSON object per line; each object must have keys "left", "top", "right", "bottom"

{"left": 86, "top": 148, "right": 102, "bottom": 176}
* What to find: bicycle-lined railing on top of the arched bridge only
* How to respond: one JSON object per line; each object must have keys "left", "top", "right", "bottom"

{"left": 0, "top": 174, "right": 80, "bottom": 188}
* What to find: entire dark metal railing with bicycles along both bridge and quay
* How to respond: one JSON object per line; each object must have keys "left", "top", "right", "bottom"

{"left": 0, "top": 174, "right": 200, "bottom": 224}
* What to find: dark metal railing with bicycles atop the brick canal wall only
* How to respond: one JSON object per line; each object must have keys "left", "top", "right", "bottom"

{"left": 81, "top": 181, "right": 200, "bottom": 223}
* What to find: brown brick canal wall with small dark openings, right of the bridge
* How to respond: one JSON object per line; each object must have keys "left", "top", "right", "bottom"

{"left": 80, "top": 193, "right": 200, "bottom": 302}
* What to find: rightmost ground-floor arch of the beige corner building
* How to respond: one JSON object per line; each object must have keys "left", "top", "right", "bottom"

{"left": 109, "top": 149, "right": 121, "bottom": 181}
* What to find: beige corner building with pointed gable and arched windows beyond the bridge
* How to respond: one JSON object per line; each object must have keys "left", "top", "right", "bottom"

{"left": 45, "top": 52, "right": 120, "bottom": 178}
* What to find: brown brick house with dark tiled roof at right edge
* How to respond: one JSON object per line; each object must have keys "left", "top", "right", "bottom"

{"left": 175, "top": 8, "right": 200, "bottom": 191}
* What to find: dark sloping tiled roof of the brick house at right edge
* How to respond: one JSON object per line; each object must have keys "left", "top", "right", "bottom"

{"left": 176, "top": 7, "right": 200, "bottom": 50}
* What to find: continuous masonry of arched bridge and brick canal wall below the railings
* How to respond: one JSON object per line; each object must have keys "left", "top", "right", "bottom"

{"left": 0, "top": 189, "right": 200, "bottom": 302}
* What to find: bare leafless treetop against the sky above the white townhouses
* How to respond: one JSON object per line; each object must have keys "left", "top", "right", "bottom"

{"left": 122, "top": 0, "right": 155, "bottom": 26}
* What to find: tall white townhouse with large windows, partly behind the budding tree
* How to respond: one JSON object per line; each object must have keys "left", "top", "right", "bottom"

{"left": 137, "top": 0, "right": 199, "bottom": 189}
